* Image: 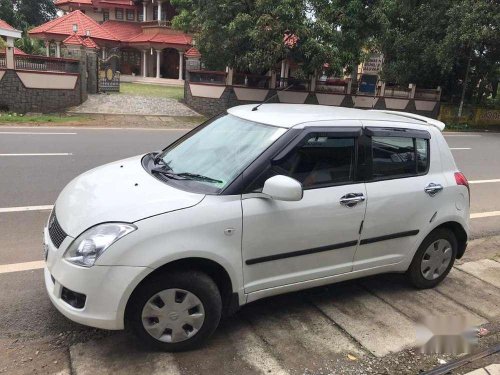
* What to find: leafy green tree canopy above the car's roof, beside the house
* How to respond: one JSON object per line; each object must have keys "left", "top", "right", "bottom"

{"left": 172, "top": 0, "right": 372, "bottom": 76}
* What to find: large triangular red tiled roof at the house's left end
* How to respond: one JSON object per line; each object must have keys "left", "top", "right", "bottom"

{"left": 29, "top": 10, "right": 118, "bottom": 41}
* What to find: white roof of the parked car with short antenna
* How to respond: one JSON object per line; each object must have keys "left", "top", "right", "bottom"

{"left": 227, "top": 103, "right": 445, "bottom": 131}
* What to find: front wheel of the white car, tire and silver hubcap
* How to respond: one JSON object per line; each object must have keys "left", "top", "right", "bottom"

{"left": 127, "top": 271, "right": 222, "bottom": 352}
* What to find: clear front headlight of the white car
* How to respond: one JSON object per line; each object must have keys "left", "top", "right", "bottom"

{"left": 64, "top": 223, "right": 137, "bottom": 267}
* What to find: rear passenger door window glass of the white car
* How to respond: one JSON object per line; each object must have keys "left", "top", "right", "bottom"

{"left": 372, "top": 137, "right": 429, "bottom": 179}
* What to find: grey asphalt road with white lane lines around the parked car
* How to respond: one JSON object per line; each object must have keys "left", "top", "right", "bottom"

{"left": 0, "top": 127, "right": 500, "bottom": 372}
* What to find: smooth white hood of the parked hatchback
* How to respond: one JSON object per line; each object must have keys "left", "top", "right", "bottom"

{"left": 56, "top": 156, "right": 205, "bottom": 237}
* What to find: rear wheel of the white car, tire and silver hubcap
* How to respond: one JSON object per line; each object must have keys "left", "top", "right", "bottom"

{"left": 406, "top": 228, "right": 458, "bottom": 289}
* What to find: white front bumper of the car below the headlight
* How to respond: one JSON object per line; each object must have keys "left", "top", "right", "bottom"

{"left": 44, "top": 226, "right": 150, "bottom": 330}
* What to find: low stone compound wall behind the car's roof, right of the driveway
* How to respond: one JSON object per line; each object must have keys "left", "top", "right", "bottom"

{"left": 184, "top": 81, "right": 440, "bottom": 118}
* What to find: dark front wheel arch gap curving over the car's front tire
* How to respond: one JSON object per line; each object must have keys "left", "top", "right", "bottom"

{"left": 124, "top": 257, "right": 240, "bottom": 321}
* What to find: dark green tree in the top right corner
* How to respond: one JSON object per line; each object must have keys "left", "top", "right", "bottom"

{"left": 372, "top": 0, "right": 500, "bottom": 102}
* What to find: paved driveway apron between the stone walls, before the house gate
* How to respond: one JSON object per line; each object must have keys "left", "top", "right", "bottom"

{"left": 69, "top": 94, "right": 199, "bottom": 116}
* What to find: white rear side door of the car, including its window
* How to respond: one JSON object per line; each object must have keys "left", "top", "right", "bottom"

{"left": 353, "top": 121, "right": 446, "bottom": 271}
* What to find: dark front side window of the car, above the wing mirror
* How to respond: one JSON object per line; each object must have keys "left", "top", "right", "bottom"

{"left": 249, "top": 134, "right": 356, "bottom": 191}
